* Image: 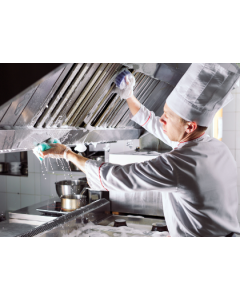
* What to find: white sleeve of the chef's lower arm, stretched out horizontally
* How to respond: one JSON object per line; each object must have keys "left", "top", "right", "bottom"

{"left": 86, "top": 154, "right": 178, "bottom": 192}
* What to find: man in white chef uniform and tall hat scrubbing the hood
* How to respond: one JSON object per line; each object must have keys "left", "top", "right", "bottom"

{"left": 39, "top": 63, "right": 240, "bottom": 237}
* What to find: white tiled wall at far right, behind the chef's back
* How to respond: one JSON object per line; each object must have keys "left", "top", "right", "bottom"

{"left": 223, "top": 87, "right": 240, "bottom": 222}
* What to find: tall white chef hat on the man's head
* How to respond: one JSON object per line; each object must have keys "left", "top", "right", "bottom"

{"left": 167, "top": 63, "right": 240, "bottom": 127}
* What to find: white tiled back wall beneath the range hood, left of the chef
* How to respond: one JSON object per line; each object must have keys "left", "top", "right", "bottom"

{"left": 0, "top": 140, "right": 139, "bottom": 213}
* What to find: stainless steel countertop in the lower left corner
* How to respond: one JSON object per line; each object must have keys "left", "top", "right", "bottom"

{"left": 0, "top": 198, "right": 59, "bottom": 237}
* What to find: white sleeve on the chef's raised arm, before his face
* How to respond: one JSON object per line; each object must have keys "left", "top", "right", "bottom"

{"left": 132, "top": 105, "right": 179, "bottom": 149}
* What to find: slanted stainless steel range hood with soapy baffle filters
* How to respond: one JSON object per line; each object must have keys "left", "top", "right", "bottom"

{"left": 0, "top": 63, "right": 238, "bottom": 152}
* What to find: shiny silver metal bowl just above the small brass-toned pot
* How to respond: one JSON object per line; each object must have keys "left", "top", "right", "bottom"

{"left": 55, "top": 179, "right": 88, "bottom": 198}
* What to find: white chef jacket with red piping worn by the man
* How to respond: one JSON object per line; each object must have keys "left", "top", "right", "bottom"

{"left": 86, "top": 106, "right": 240, "bottom": 237}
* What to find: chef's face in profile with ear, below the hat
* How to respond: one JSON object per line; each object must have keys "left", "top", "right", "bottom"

{"left": 160, "top": 104, "right": 197, "bottom": 142}
